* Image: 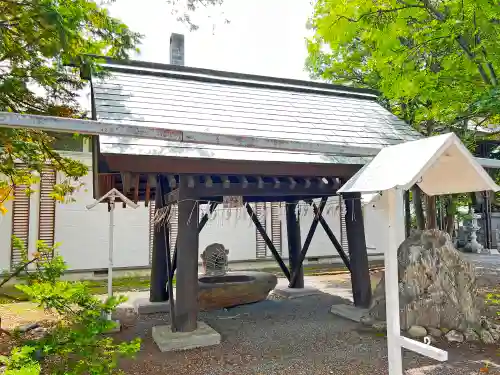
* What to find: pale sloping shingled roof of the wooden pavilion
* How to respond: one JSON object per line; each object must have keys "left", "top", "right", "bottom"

{"left": 93, "top": 60, "right": 419, "bottom": 164}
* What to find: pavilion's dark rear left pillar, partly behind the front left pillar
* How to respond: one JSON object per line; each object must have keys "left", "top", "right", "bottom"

{"left": 149, "top": 180, "right": 168, "bottom": 302}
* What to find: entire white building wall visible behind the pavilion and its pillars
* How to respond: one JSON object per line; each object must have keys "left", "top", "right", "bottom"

{"left": 0, "top": 153, "right": 387, "bottom": 270}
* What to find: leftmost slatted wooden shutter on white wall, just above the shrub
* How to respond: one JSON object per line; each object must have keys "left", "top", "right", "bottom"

{"left": 10, "top": 185, "right": 30, "bottom": 271}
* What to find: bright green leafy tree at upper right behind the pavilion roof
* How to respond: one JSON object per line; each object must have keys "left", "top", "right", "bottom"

{"left": 306, "top": 0, "right": 500, "bottom": 229}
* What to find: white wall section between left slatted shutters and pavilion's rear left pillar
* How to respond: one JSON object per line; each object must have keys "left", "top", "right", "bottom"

{"left": 55, "top": 155, "right": 149, "bottom": 270}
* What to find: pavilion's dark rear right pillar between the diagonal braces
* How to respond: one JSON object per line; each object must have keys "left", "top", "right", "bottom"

{"left": 285, "top": 202, "right": 304, "bottom": 288}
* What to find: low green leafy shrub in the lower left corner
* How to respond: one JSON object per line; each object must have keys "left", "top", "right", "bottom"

{"left": 0, "top": 241, "right": 140, "bottom": 375}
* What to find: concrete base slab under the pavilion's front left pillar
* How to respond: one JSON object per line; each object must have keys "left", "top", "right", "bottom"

{"left": 152, "top": 322, "right": 221, "bottom": 352}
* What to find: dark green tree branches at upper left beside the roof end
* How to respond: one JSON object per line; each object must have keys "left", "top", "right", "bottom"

{"left": 0, "top": 0, "right": 140, "bottom": 212}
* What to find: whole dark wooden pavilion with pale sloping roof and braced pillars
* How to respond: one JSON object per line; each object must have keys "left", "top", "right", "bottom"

{"left": 88, "top": 59, "right": 419, "bottom": 332}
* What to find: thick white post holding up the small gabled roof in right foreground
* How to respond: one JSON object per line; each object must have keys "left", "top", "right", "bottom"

{"left": 384, "top": 189, "right": 405, "bottom": 375}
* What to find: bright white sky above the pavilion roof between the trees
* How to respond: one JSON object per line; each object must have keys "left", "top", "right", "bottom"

{"left": 105, "top": 0, "right": 312, "bottom": 79}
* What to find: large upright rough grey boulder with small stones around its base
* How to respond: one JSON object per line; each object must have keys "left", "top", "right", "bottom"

{"left": 362, "top": 230, "right": 500, "bottom": 344}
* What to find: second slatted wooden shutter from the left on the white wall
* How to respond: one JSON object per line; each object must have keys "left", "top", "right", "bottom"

{"left": 38, "top": 167, "right": 56, "bottom": 250}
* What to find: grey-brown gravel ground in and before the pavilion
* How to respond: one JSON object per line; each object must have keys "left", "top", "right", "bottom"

{"left": 114, "top": 294, "right": 500, "bottom": 375}
